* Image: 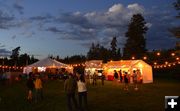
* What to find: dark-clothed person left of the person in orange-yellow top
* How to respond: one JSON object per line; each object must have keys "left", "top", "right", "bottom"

{"left": 26, "top": 73, "right": 34, "bottom": 102}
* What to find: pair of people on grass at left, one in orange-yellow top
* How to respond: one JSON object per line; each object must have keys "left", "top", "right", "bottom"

{"left": 26, "top": 73, "right": 43, "bottom": 102}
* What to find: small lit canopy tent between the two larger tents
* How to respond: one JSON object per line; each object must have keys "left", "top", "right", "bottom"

{"left": 85, "top": 60, "right": 103, "bottom": 76}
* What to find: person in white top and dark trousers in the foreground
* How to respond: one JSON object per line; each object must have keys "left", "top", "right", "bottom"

{"left": 77, "top": 74, "right": 87, "bottom": 111}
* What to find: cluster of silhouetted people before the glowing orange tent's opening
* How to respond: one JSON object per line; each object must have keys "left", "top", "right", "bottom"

{"left": 114, "top": 69, "right": 142, "bottom": 90}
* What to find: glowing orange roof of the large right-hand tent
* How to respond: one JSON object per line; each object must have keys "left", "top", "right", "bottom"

{"left": 105, "top": 60, "right": 149, "bottom": 68}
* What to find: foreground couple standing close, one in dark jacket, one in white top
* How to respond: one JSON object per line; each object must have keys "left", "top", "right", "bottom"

{"left": 64, "top": 74, "right": 88, "bottom": 111}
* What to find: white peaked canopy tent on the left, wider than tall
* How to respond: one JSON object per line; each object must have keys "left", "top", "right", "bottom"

{"left": 23, "top": 58, "right": 73, "bottom": 74}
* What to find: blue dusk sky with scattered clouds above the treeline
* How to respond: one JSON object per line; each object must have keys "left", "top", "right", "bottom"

{"left": 0, "top": 0, "right": 180, "bottom": 59}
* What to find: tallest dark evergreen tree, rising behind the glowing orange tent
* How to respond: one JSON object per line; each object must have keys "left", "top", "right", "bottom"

{"left": 123, "top": 14, "right": 148, "bottom": 59}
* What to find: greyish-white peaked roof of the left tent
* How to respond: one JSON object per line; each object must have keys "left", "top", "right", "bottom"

{"left": 27, "top": 58, "right": 68, "bottom": 68}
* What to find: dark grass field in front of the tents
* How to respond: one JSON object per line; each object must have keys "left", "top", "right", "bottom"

{"left": 0, "top": 78, "right": 180, "bottom": 111}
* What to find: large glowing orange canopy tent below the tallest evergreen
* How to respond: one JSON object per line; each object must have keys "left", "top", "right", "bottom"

{"left": 104, "top": 60, "right": 153, "bottom": 83}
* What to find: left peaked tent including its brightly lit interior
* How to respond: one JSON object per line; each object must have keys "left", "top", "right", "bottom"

{"left": 23, "top": 58, "right": 73, "bottom": 74}
